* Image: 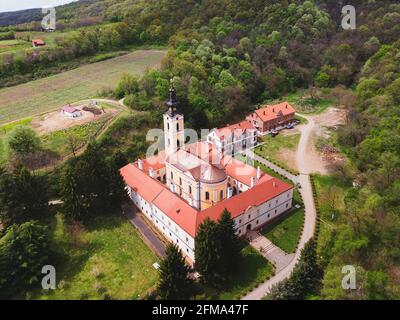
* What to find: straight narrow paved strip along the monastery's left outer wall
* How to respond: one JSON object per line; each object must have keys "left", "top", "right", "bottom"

{"left": 122, "top": 204, "right": 165, "bottom": 257}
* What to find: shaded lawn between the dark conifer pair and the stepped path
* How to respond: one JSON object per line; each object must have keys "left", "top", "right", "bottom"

{"left": 211, "top": 245, "right": 274, "bottom": 300}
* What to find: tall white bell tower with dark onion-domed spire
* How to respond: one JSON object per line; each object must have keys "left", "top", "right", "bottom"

{"left": 164, "top": 79, "right": 185, "bottom": 157}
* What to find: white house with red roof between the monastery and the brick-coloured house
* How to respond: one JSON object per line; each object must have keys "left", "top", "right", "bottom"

{"left": 207, "top": 120, "right": 257, "bottom": 155}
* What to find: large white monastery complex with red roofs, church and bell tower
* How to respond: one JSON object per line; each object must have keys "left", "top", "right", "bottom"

{"left": 120, "top": 85, "right": 293, "bottom": 262}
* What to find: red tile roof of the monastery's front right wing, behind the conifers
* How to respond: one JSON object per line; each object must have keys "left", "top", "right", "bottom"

{"left": 197, "top": 178, "right": 293, "bottom": 227}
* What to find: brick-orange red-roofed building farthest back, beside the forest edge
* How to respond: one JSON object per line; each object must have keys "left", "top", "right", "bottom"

{"left": 246, "top": 102, "right": 296, "bottom": 133}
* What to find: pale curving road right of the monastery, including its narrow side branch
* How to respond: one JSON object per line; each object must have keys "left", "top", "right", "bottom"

{"left": 242, "top": 116, "right": 317, "bottom": 300}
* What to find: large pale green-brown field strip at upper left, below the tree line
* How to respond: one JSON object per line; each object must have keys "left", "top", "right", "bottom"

{"left": 0, "top": 50, "right": 165, "bottom": 125}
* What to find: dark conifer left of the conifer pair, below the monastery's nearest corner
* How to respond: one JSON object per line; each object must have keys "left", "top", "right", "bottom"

{"left": 157, "top": 244, "right": 194, "bottom": 300}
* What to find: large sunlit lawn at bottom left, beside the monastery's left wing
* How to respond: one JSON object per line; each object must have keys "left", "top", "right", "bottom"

{"left": 32, "top": 214, "right": 159, "bottom": 299}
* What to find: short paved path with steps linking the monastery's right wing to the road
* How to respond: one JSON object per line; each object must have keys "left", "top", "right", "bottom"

{"left": 246, "top": 231, "right": 294, "bottom": 272}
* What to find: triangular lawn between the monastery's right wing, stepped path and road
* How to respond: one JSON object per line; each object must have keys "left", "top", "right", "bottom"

{"left": 261, "top": 208, "right": 304, "bottom": 253}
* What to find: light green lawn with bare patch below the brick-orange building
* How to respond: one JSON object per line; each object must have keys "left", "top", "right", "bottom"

{"left": 254, "top": 134, "right": 300, "bottom": 171}
